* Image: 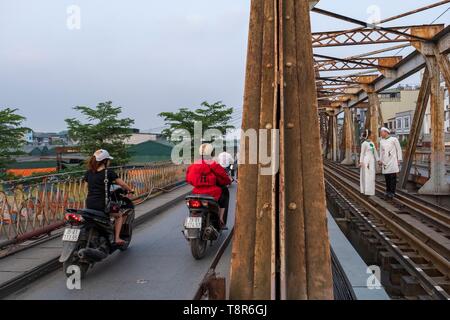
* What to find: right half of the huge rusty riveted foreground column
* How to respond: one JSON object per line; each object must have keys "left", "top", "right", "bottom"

{"left": 278, "top": 0, "right": 333, "bottom": 300}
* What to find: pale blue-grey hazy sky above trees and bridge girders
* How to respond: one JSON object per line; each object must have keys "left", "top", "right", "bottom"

{"left": 0, "top": 0, "right": 450, "bottom": 132}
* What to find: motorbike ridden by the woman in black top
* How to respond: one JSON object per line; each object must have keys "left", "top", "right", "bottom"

{"left": 59, "top": 187, "right": 135, "bottom": 278}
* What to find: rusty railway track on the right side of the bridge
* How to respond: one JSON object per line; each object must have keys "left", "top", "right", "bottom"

{"left": 325, "top": 162, "right": 450, "bottom": 300}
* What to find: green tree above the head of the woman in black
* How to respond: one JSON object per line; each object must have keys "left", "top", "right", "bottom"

{"left": 66, "top": 101, "right": 134, "bottom": 165}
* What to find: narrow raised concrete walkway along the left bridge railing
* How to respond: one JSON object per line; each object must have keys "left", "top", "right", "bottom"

{"left": 0, "top": 186, "right": 192, "bottom": 287}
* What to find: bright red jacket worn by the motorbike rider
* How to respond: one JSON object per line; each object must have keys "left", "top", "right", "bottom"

{"left": 186, "top": 160, "right": 231, "bottom": 201}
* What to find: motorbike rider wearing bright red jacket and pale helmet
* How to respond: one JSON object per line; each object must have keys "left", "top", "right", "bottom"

{"left": 186, "top": 144, "right": 231, "bottom": 225}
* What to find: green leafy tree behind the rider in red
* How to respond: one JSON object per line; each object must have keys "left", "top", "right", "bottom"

{"left": 159, "top": 101, "right": 234, "bottom": 139}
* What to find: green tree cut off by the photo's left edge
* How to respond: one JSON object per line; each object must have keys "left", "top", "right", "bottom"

{"left": 0, "top": 108, "right": 30, "bottom": 166}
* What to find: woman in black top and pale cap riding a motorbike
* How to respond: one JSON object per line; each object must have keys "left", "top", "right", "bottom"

{"left": 84, "top": 149, "right": 133, "bottom": 246}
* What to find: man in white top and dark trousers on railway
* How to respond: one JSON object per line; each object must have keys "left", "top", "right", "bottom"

{"left": 380, "top": 127, "right": 403, "bottom": 199}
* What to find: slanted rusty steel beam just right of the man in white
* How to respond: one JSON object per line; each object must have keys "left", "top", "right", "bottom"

{"left": 399, "top": 68, "right": 431, "bottom": 188}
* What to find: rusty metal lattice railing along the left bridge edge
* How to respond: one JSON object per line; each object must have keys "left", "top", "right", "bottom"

{"left": 0, "top": 162, "right": 186, "bottom": 244}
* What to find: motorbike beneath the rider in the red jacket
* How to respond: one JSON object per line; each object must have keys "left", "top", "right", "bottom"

{"left": 183, "top": 195, "right": 228, "bottom": 260}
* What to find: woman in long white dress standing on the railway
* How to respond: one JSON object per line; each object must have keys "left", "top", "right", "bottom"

{"left": 359, "top": 130, "right": 379, "bottom": 196}
